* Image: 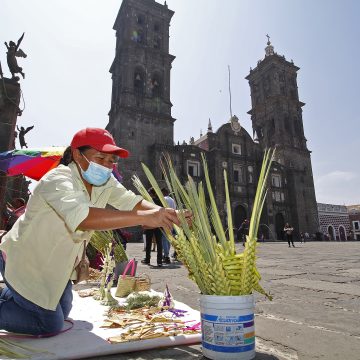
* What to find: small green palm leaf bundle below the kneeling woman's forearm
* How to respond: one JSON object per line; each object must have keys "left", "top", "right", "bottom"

{"left": 90, "top": 230, "right": 129, "bottom": 263}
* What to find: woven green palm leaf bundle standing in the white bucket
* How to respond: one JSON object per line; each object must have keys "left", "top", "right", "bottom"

{"left": 133, "top": 149, "right": 275, "bottom": 299}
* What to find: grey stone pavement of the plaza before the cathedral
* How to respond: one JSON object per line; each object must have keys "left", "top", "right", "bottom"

{"left": 85, "top": 242, "right": 360, "bottom": 360}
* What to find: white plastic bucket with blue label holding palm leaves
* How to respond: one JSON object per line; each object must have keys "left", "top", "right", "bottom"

{"left": 200, "top": 295, "right": 255, "bottom": 360}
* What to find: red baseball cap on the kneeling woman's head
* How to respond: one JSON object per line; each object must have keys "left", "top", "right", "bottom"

{"left": 70, "top": 128, "right": 129, "bottom": 158}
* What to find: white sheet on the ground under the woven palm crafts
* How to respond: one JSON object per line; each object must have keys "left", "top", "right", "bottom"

{"left": 1, "top": 289, "right": 201, "bottom": 360}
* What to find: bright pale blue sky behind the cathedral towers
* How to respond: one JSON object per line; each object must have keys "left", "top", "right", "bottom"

{"left": 0, "top": 0, "right": 360, "bottom": 204}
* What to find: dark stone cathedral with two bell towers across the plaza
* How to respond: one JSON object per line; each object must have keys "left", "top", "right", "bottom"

{"left": 107, "top": 0, "right": 319, "bottom": 240}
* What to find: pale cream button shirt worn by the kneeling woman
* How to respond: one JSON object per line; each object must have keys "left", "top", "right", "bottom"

{"left": 0, "top": 162, "right": 143, "bottom": 310}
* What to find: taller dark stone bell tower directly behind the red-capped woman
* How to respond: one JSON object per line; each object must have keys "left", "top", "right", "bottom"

{"left": 107, "top": 0, "right": 175, "bottom": 188}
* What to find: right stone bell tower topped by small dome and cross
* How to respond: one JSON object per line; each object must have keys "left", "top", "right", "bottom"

{"left": 246, "top": 37, "right": 319, "bottom": 233}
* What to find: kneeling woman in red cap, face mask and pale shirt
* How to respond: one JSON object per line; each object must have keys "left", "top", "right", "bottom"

{"left": 0, "top": 128, "right": 179, "bottom": 335}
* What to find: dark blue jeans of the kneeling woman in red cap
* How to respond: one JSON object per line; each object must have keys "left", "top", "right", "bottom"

{"left": 0, "top": 251, "right": 73, "bottom": 335}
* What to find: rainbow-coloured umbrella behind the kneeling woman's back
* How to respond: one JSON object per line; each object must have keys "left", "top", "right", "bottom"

{"left": 0, "top": 147, "right": 65, "bottom": 180}
